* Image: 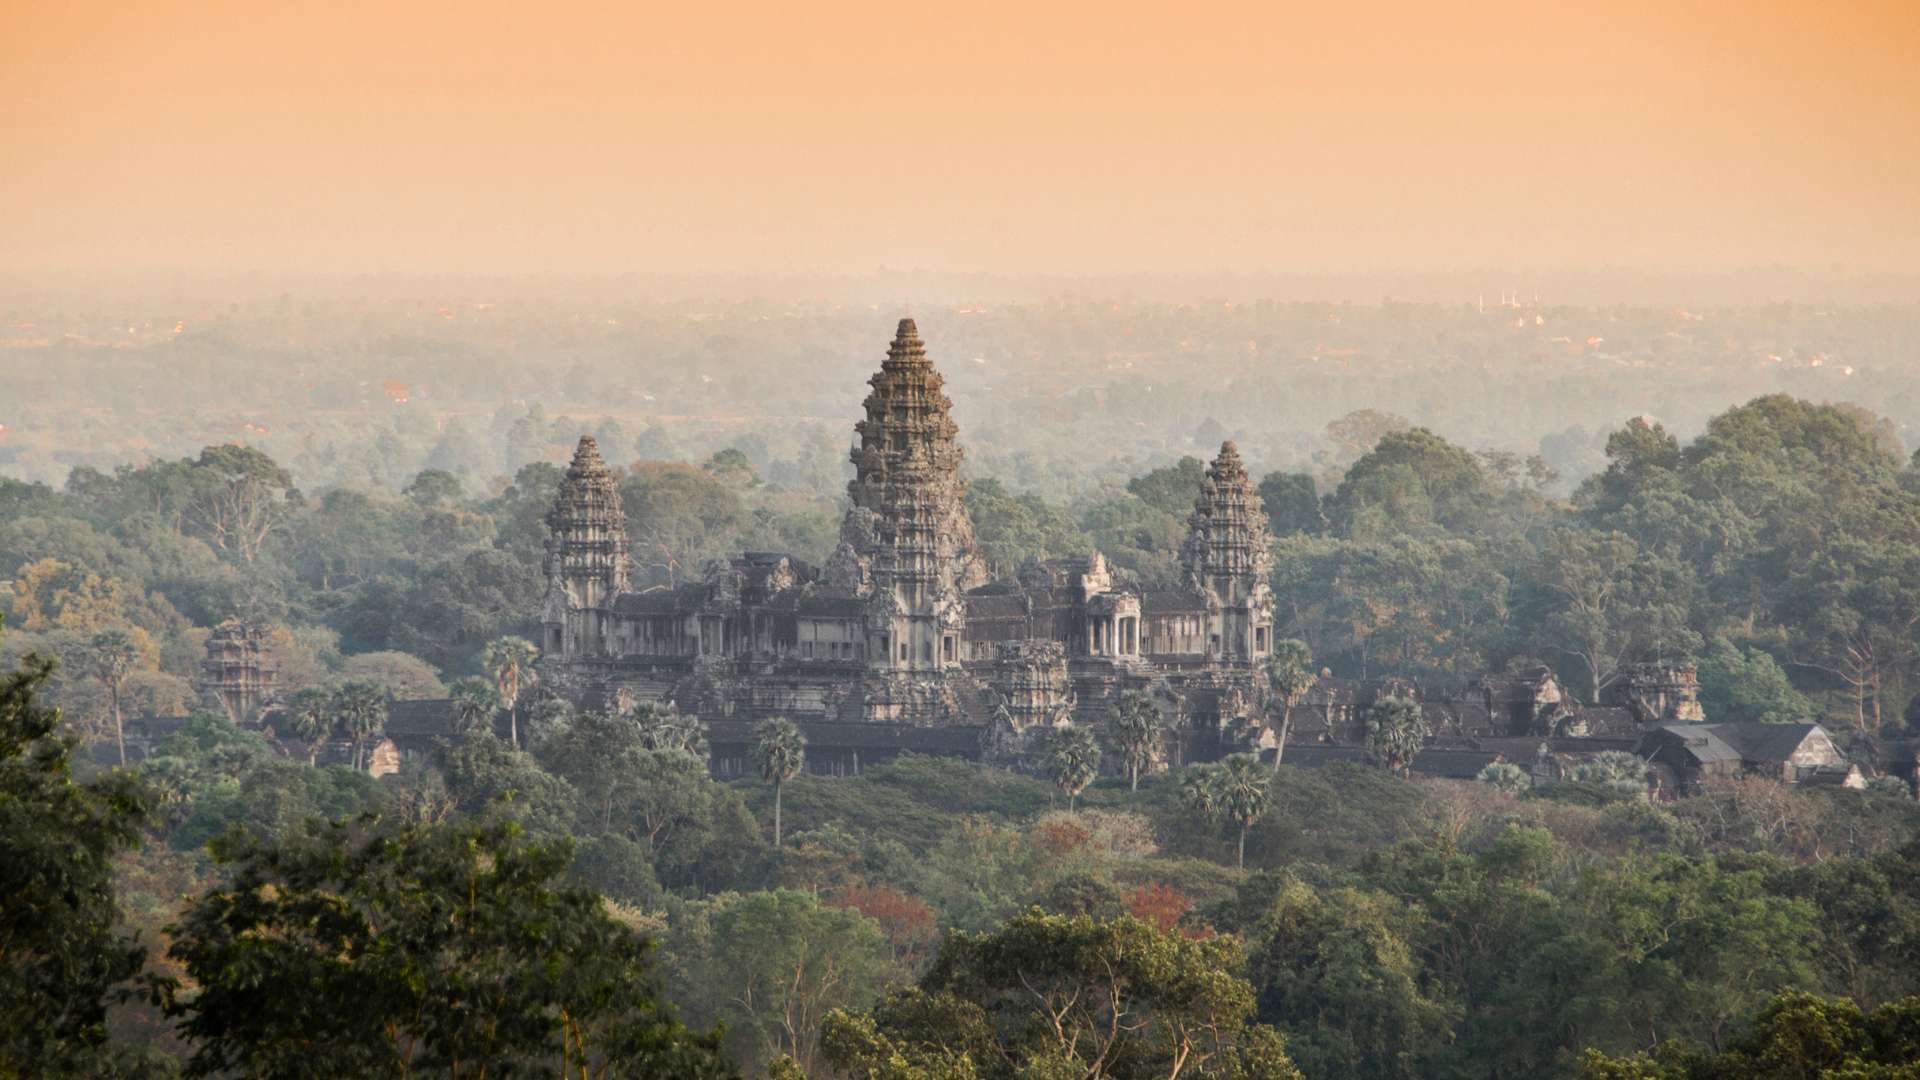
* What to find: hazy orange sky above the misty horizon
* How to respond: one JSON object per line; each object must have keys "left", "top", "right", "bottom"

{"left": 0, "top": 0, "right": 1920, "bottom": 273}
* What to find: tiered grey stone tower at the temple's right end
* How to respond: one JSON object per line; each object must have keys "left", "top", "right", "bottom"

{"left": 1181, "top": 440, "right": 1273, "bottom": 663}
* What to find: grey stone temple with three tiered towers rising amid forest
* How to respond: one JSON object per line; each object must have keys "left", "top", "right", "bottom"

{"left": 541, "top": 319, "right": 1273, "bottom": 776}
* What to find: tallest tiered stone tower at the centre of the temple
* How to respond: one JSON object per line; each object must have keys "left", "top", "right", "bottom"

{"left": 829, "top": 319, "right": 987, "bottom": 671}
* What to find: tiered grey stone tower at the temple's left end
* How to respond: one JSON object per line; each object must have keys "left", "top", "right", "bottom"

{"left": 541, "top": 434, "right": 628, "bottom": 659}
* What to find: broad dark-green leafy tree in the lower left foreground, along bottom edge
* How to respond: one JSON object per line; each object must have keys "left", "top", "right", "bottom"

{"left": 159, "top": 822, "right": 732, "bottom": 1080}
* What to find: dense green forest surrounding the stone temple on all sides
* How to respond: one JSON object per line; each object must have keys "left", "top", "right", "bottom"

{"left": 11, "top": 396, "right": 1920, "bottom": 1080}
